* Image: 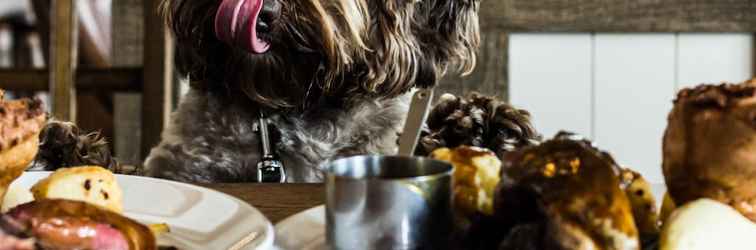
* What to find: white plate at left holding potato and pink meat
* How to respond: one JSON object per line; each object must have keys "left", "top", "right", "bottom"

{"left": 12, "top": 172, "right": 275, "bottom": 250}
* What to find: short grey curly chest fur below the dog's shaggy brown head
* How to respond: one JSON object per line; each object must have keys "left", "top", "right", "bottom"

{"left": 145, "top": 90, "right": 409, "bottom": 183}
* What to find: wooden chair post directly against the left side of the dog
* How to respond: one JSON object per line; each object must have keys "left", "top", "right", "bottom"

{"left": 142, "top": 0, "right": 174, "bottom": 158}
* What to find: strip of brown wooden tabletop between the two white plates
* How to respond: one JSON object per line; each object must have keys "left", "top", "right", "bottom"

{"left": 204, "top": 183, "right": 325, "bottom": 224}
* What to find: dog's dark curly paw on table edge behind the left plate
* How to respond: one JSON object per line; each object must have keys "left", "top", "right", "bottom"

{"left": 30, "top": 121, "right": 118, "bottom": 171}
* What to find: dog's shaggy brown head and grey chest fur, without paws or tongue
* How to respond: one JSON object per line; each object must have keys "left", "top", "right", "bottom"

{"left": 145, "top": 0, "right": 480, "bottom": 182}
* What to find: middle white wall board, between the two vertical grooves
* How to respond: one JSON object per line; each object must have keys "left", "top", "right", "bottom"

{"left": 594, "top": 34, "right": 675, "bottom": 182}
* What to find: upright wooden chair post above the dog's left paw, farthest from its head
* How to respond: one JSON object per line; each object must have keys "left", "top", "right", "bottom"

{"left": 50, "top": 0, "right": 79, "bottom": 122}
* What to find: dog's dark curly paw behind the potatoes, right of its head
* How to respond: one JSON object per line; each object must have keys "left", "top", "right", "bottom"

{"left": 415, "top": 93, "right": 541, "bottom": 157}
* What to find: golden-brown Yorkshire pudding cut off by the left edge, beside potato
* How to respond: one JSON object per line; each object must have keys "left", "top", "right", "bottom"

{"left": 0, "top": 90, "right": 47, "bottom": 209}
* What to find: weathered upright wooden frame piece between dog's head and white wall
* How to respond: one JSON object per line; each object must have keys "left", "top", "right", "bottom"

{"left": 436, "top": 28, "right": 509, "bottom": 100}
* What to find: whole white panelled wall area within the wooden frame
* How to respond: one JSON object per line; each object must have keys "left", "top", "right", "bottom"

{"left": 509, "top": 33, "right": 753, "bottom": 183}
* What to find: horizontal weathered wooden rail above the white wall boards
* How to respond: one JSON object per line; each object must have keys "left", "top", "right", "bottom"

{"left": 488, "top": 0, "right": 756, "bottom": 33}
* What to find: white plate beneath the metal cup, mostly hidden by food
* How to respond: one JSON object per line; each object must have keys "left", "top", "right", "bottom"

{"left": 275, "top": 184, "right": 666, "bottom": 250}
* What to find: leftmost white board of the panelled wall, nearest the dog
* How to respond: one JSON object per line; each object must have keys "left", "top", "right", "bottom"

{"left": 509, "top": 34, "right": 592, "bottom": 137}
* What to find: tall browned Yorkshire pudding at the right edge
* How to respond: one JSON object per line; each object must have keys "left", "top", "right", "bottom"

{"left": 663, "top": 82, "right": 756, "bottom": 221}
